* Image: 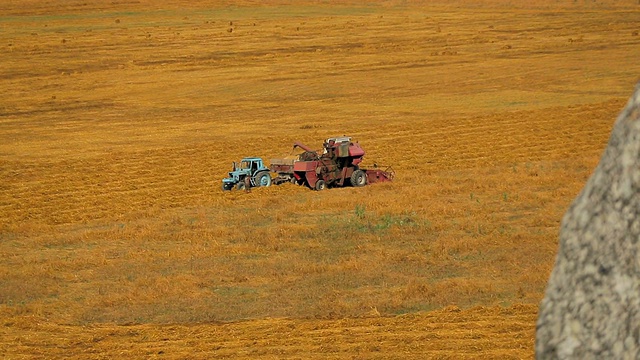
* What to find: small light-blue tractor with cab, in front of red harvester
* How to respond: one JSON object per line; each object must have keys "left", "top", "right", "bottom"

{"left": 222, "top": 157, "right": 271, "bottom": 191}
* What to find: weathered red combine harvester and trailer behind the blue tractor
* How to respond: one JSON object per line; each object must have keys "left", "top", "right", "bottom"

{"left": 270, "top": 136, "right": 395, "bottom": 190}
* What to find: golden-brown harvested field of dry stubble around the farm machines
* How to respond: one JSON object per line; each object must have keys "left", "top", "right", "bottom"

{"left": 0, "top": 0, "right": 640, "bottom": 359}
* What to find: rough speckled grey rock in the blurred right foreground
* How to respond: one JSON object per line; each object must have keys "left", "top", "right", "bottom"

{"left": 535, "top": 84, "right": 640, "bottom": 359}
